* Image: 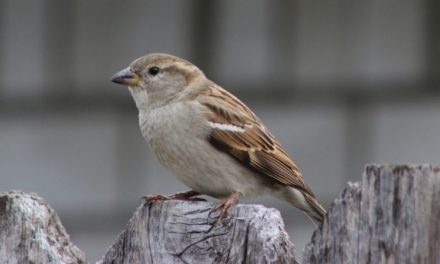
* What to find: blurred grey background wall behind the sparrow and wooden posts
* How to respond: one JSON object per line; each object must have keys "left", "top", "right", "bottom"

{"left": 0, "top": 0, "right": 440, "bottom": 261}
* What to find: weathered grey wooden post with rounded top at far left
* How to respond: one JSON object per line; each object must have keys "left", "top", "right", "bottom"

{"left": 0, "top": 191, "right": 86, "bottom": 264}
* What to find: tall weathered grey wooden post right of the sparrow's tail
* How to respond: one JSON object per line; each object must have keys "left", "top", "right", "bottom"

{"left": 303, "top": 165, "right": 440, "bottom": 264}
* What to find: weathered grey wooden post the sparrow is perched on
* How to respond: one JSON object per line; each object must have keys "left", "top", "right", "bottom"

{"left": 98, "top": 201, "right": 294, "bottom": 264}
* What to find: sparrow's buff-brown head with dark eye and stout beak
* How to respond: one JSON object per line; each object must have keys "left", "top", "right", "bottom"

{"left": 111, "top": 53, "right": 204, "bottom": 108}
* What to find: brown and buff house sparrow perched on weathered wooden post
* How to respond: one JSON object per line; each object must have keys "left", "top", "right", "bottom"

{"left": 111, "top": 53, "right": 326, "bottom": 224}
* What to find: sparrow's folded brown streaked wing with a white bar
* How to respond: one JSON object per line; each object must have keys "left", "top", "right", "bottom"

{"left": 197, "top": 84, "right": 315, "bottom": 197}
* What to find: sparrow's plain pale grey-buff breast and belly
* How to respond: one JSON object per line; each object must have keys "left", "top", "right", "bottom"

{"left": 139, "top": 101, "right": 270, "bottom": 197}
